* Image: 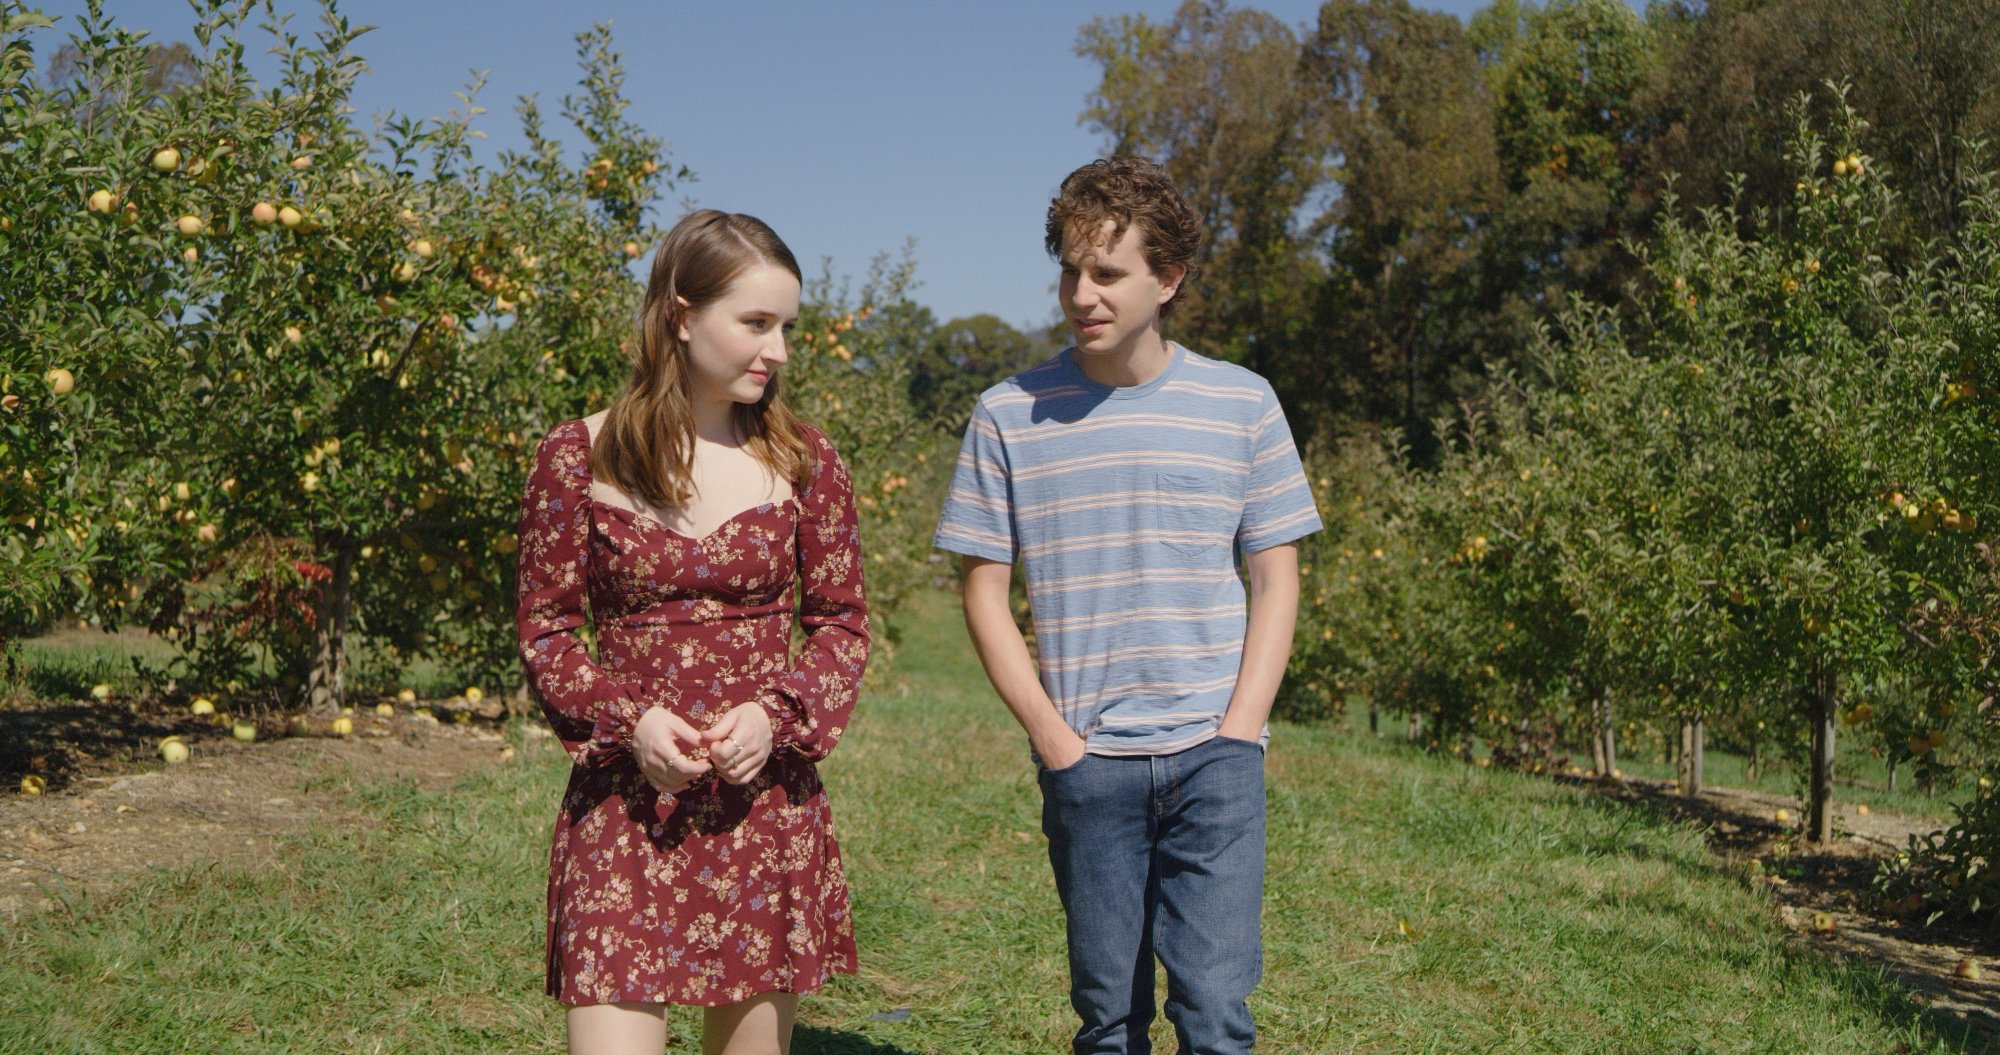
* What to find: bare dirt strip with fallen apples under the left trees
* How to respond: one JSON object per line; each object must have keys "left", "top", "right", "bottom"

{"left": 0, "top": 703, "right": 520, "bottom": 925}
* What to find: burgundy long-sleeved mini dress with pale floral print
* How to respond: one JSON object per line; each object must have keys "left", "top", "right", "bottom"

{"left": 518, "top": 422, "right": 868, "bottom": 1005}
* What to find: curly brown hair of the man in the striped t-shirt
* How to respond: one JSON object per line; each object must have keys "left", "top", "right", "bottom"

{"left": 1042, "top": 154, "right": 1202, "bottom": 318}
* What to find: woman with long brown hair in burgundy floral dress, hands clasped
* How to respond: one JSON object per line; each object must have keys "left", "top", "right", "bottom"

{"left": 518, "top": 210, "right": 868, "bottom": 1055}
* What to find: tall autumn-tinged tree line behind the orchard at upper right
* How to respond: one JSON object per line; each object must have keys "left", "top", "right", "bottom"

{"left": 1076, "top": 0, "right": 2000, "bottom": 462}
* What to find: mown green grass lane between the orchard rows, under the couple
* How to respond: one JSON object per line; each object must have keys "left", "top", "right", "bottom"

{"left": 0, "top": 597, "right": 1984, "bottom": 1055}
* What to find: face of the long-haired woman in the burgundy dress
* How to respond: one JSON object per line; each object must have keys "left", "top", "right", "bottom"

{"left": 680, "top": 264, "right": 798, "bottom": 404}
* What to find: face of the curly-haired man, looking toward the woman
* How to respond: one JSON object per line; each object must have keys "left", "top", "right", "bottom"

{"left": 1058, "top": 220, "right": 1180, "bottom": 356}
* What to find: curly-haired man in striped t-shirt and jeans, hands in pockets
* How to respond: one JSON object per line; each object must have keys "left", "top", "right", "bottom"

{"left": 936, "top": 158, "right": 1320, "bottom": 1055}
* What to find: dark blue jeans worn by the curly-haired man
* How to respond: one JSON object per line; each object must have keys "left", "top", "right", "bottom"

{"left": 1040, "top": 737, "right": 1264, "bottom": 1055}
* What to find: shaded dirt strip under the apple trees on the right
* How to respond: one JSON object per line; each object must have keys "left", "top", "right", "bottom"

{"left": 1580, "top": 779, "right": 2000, "bottom": 1051}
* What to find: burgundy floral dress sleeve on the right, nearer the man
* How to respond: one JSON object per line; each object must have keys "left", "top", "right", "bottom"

{"left": 762, "top": 430, "right": 868, "bottom": 761}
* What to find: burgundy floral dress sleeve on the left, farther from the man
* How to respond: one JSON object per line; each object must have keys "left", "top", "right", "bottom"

{"left": 516, "top": 422, "right": 646, "bottom": 767}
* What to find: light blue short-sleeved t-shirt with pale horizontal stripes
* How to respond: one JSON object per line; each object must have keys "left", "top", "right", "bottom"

{"left": 936, "top": 344, "right": 1320, "bottom": 755}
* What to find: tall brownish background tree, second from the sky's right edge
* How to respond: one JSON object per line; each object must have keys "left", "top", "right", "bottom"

{"left": 1294, "top": 0, "right": 1500, "bottom": 450}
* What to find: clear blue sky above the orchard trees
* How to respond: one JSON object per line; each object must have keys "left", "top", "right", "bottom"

{"left": 36, "top": 0, "right": 1544, "bottom": 326}
